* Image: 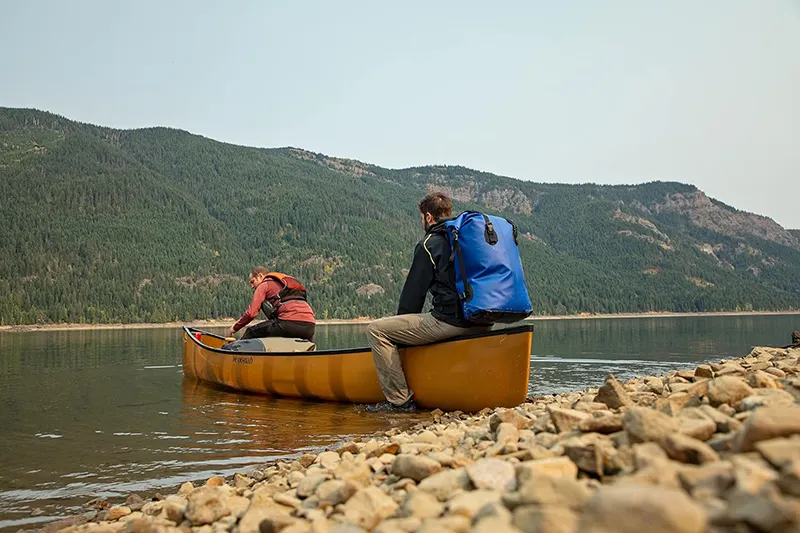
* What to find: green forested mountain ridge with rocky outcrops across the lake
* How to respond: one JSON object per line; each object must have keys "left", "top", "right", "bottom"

{"left": 0, "top": 108, "right": 800, "bottom": 324}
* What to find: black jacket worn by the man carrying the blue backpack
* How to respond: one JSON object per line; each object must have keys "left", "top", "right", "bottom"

{"left": 397, "top": 218, "right": 472, "bottom": 327}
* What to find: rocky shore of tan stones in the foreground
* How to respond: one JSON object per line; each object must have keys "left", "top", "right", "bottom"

{"left": 36, "top": 348, "right": 800, "bottom": 533}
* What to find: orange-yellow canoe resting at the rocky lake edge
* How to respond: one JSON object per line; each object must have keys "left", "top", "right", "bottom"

{"left": 183, "top": 325, "right": 533, "bottom": 412}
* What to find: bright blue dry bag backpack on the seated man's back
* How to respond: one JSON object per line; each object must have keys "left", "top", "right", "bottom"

{"left": 445, "top": 211, "right": 533, "bottom": 324}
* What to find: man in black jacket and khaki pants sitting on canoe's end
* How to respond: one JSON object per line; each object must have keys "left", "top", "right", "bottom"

{"left": 366, "top": 192, "right": 491, "bottom": 413}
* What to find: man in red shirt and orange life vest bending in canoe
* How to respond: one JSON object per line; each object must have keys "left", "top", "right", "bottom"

{"left": 227, "top": 266, "right": 316, "bottom": 341}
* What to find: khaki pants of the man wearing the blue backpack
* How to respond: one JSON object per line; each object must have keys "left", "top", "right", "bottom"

{"left": 367, "top": 313, "right": 490, "bottom": 405}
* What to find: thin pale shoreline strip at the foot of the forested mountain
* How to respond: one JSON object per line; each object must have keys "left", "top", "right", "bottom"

{"left": 0, "top": 310, "right": 800, "bottom": 333}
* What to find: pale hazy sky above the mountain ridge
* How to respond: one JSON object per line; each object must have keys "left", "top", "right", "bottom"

{"left": 0, "top": 0, "right": 800, "bottom": 228}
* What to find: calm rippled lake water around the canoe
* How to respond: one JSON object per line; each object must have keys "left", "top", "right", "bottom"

{"left": 0, "top": 315, "right": 800, "bottom": 531}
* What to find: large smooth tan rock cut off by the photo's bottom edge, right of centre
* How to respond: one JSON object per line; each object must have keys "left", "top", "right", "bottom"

{"left": 577, "top": 485, "right": 707, "bottom": 533}
